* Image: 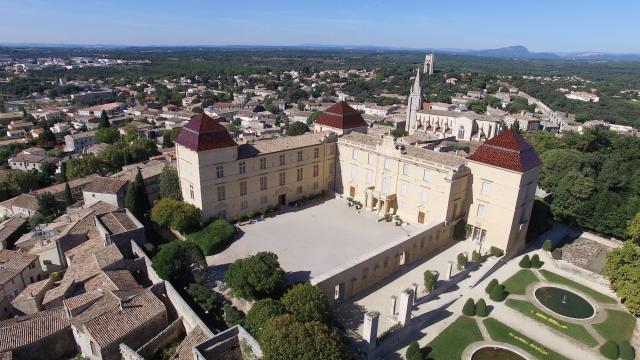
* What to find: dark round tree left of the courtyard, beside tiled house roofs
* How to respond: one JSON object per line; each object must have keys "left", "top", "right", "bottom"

{"left": 151, "top": 240, "right": 207, "bottom": 287}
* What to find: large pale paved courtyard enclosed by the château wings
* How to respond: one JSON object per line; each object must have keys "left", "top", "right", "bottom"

{"left": 207, "top": 199, "right": 420, "bottom": 281}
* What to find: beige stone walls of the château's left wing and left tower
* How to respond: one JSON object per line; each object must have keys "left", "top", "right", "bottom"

{"left": 177, "top": 142, "right": 336, "bottom": 219}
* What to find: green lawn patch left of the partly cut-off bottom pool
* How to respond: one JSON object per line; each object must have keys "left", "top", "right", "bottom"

{"left": 423, "top": 315, "right": 483, "bottom": 360}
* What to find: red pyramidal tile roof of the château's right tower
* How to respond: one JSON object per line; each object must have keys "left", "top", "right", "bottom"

{"left": 467, "top": 130, "right": 542, "bottom": 173}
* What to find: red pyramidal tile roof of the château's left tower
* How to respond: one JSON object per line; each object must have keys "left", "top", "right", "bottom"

{"left": 176, "top": 114, "right": 238, "bottom": 151}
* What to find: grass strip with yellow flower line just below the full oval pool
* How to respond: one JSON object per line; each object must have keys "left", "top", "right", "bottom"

{"left": 505, "top": 299, "right": 598, "bottom": 347}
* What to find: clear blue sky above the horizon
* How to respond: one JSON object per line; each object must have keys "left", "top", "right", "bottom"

{"left": 0, "top": 0, "right": 640, "bottom": 53}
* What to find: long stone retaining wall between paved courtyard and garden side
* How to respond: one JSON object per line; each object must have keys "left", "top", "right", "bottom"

{"left": 311, "top": 222, "right": 454, "bottom": 304}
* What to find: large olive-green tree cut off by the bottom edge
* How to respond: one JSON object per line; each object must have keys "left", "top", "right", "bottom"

{"left": 260, "top": 315, "right": 347, "bottom": 360}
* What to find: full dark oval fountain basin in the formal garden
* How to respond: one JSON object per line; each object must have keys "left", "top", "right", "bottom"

{"left": 534, "top": 286, "right": 596, "bottom": 320}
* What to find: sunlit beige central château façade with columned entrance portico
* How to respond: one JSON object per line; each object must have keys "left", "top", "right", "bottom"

{"left": 336, "top": 135, "right": 470, "bottom": 224}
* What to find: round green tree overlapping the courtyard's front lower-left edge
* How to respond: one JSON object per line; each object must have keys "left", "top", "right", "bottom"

{"left": 224, "top": 252, "right": 286, "bottom": 300}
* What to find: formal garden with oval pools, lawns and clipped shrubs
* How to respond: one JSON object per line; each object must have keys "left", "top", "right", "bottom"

{"left": 406, "top": 248, "right": 636, "bottom": 360}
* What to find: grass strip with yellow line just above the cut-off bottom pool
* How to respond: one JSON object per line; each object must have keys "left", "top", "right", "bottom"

{"left": 482, "top": 318, "right": 568, "bottom": 360}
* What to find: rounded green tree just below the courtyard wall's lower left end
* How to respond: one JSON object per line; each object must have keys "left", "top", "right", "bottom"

{"left": 282, "top": 283, "right": 331, "bottom": 325}
